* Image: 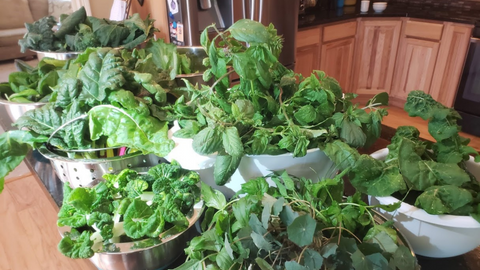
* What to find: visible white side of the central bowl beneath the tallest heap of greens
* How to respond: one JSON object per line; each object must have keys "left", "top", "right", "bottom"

{"left": 165, "top": 123, "right": 335, "bottom": 199}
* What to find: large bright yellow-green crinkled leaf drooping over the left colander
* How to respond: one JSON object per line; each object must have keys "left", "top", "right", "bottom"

{"left": 88, "top": 105, "right": 175, "bottom": 157}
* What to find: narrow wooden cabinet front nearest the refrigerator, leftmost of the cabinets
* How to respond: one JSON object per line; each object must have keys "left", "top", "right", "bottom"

{"left": 295, "top": 27, "right": 321, "bottom": 77}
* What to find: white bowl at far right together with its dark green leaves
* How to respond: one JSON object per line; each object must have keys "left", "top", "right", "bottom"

{"left": 326, "top": 91, "right": 480, "bottom": 257}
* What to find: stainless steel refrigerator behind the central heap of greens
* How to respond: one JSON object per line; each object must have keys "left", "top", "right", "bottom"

{"left": 167, "top": 0, "right": 299, "bottom": 68}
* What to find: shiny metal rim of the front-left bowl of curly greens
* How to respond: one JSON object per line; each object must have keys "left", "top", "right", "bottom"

{"left": 58, "top": 200, "right": 205, "bottom": 255}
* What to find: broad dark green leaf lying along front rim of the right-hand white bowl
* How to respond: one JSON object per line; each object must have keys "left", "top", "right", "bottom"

{"left": 415, "top": 185, "right": 473, "bottom": 215}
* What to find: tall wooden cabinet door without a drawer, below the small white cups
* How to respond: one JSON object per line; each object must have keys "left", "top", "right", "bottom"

{"left": 352, "top": 19, "right": 402, "bottom": 95}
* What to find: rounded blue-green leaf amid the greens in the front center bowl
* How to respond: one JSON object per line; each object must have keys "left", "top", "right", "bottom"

{"left": 287, "top": 215, "right": 317, "bottom": 247}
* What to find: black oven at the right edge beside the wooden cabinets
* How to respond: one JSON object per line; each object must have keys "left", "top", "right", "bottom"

{"left": 454, "top": 35, "right": 480, "bottom": 136}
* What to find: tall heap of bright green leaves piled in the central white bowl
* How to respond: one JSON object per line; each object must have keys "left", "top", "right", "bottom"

{"left": 167, "top": 20, "right": 388, "bottom": 185}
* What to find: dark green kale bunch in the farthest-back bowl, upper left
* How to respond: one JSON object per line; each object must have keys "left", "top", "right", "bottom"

{"left": 18, "top": 6, "right": 157, "bottom": 52}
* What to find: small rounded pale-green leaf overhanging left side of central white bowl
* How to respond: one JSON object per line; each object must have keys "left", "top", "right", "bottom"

{"left": 192, "top": 127, "right": 222, "bottom": 155}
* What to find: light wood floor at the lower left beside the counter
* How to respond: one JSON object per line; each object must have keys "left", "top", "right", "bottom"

{"left": 0, "top": 59, "right": 96, "bottom": 270}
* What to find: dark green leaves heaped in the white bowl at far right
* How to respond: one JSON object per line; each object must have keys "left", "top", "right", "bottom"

{"left": 325, "top": 91, "right": 480, "bottom": 219}
